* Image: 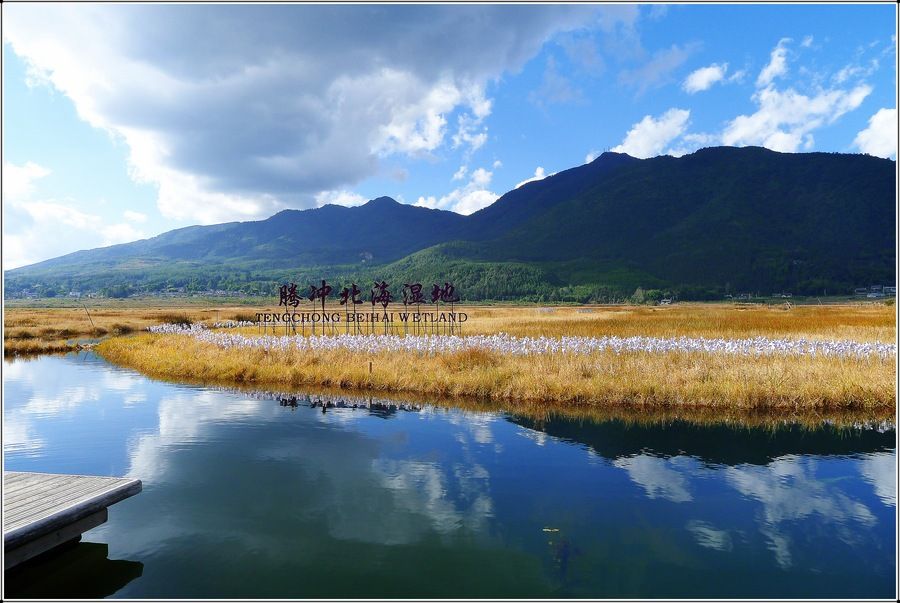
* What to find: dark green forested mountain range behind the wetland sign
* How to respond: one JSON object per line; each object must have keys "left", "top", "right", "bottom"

{"left": 5, "top": 147, "right": 896, "bottom": 301}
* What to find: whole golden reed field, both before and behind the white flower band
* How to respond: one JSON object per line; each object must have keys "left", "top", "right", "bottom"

{"left": 4, "top": 304, "right": 896, "bottom": 416}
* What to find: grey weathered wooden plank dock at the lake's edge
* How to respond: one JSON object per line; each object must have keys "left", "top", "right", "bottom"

{"left": 3, "top": 471, "right": 141, "bottom": 569}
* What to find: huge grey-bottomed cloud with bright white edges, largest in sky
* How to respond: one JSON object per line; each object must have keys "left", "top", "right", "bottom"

{"left": 4, "top": 5, "right": 616, "bottom": 223}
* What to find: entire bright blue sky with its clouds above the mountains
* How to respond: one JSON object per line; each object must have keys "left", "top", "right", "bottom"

{"left": 3, "top": 4, "right": 897, "bottom": 268}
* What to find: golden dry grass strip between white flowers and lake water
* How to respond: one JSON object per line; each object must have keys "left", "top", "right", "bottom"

{"left": 98, "top": 334, "right": 895, "bottom": 410}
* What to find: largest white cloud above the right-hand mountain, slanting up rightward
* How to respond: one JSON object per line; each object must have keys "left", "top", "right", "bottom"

{"left": 722, "top": 84, "right": 872, "bottom": 153}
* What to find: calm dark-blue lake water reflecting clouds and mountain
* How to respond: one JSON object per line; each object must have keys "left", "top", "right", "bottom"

{"left": 3, "top": 353, "right": 897, "bottom": 598}
